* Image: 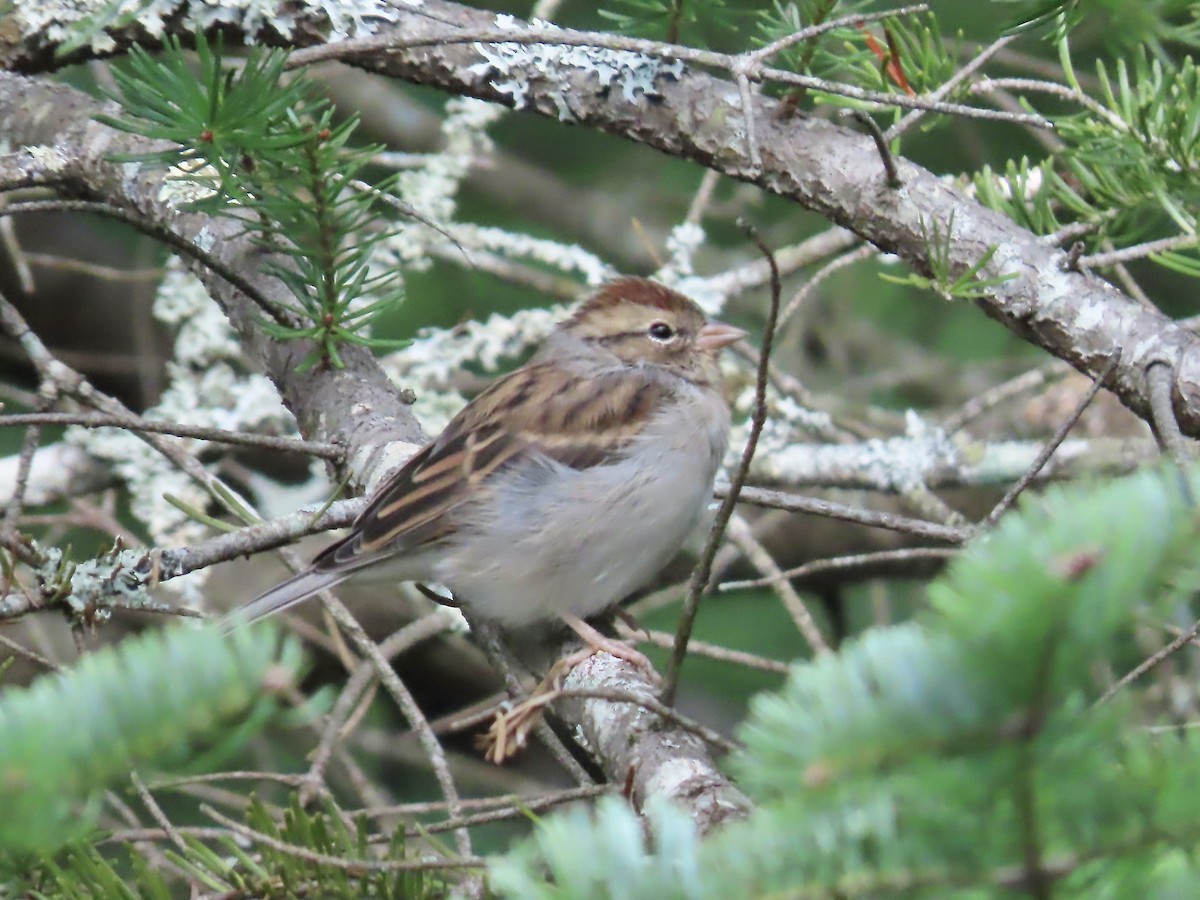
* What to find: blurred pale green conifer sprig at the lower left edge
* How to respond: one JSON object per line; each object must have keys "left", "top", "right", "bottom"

{"left": 0, "top": 628, "right": 300, "bottom": 871}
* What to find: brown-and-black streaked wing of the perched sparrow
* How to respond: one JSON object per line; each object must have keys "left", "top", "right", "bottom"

{"left": 313, "top": 364, "right": 668, "bottom": 571}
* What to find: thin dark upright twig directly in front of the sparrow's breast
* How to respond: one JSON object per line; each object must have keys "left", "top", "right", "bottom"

{"left": 662, "top": 227, "right": 781, "bottom": 706}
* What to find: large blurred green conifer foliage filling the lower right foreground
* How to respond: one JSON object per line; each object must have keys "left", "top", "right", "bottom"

{"left": 494, "top": 472, "right": 1200, "bottom": 898}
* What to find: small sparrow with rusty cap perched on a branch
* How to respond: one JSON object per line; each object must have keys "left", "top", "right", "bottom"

{"left": 223, "top": 277, "right": 745, "bottom": 667}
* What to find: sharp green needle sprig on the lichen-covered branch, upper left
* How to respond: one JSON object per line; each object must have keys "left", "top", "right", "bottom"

{"left": 101, "top": 35, "right": 402, "bottom": 370}
